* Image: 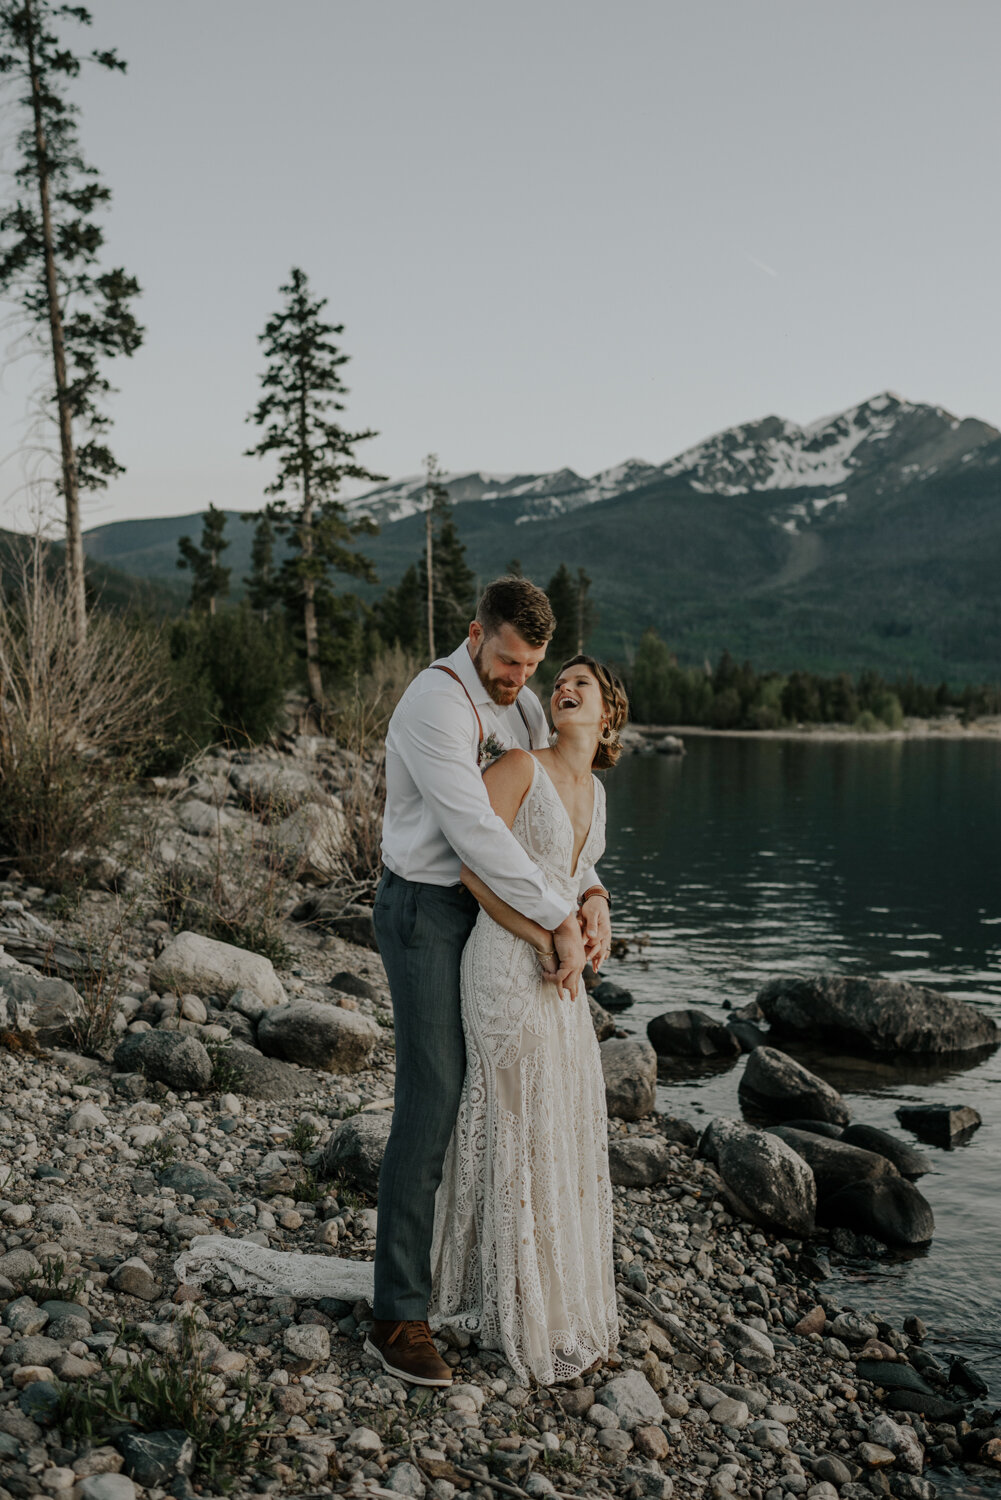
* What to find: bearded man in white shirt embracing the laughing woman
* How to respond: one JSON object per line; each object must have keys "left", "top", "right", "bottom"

{"left": 366, "top": 578, "right": 611, "bottom": 1386}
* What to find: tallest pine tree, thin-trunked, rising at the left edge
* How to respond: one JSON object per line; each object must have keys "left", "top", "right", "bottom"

{"left": 0, "top": 0, "right": 143, "bottom": 639}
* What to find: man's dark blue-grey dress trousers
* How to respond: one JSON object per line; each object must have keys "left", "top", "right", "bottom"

{"left": 372, "top": 870, "right": 479, "bottom": 1322}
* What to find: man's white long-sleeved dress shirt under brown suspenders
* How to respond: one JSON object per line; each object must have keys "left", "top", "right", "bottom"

{"left": 383, "top": 641, "right": 597, "bottom": 932}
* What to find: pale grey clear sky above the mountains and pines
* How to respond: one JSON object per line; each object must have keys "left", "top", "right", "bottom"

{"left": 0, "top": 0, "right": 1001, "bottom": 527}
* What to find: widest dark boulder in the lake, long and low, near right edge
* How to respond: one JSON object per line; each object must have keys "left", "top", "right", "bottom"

{"left": 758, "top": 974, "right": 1001, "bottom": 1053}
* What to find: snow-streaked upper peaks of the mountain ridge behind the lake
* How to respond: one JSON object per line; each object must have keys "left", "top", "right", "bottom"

{"left": 348, "top": 392, "right": 999, "bottom": 533}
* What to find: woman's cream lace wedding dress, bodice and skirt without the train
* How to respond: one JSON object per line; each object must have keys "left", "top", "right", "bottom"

{"left": 429, "top": 761, "right": 618, "bottom": 1385}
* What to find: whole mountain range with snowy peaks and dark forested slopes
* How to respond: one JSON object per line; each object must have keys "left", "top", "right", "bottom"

{"left": 84, "top": 392, "right": 1001, "bottom": 681}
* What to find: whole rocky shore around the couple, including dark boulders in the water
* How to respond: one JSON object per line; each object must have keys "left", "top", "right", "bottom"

{"left": 0, "top": 701, "right": 1001, "bottom": 1500}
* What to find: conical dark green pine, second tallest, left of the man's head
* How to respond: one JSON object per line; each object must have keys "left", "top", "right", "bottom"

{"left": 248, "top": 267, "right": 386, "bottom": 704}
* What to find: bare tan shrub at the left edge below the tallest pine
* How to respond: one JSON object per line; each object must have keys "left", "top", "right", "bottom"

{"left": 0, "top": 545, "right": 164, "bottom": 885}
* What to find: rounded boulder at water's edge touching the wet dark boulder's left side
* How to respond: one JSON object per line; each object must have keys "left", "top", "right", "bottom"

{"left": 699, "top": 1119, "right": 816, "bottom": 1239}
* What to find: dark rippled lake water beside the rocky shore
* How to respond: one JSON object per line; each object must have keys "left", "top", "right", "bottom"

{"left": 602, "top": 737, "right": 1001, "bottom": 1464}
